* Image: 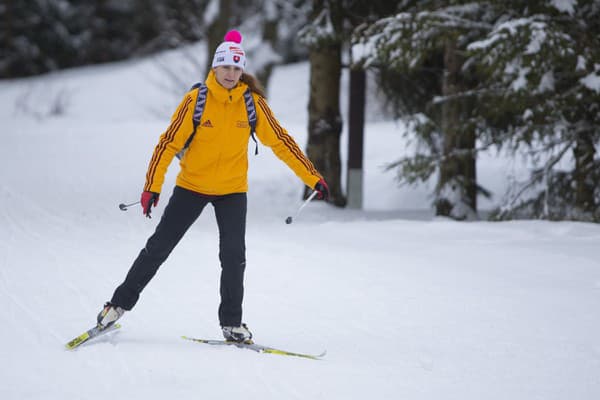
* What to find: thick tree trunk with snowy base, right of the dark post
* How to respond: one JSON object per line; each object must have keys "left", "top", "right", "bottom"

{"left": 436, "top": 39, "right": 477, "bottom": 220}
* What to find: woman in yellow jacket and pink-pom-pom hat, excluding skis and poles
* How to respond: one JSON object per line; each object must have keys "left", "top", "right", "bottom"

{"left": 97, "top": 30, "right": 329, "bottom": 342}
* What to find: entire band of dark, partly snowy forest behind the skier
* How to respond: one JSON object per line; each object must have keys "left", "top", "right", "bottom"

{"left": 0, "top": 0, "right": 600, "bottom": 222}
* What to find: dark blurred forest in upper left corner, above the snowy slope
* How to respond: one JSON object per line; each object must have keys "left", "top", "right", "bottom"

{"left": 0, "top": 0, "right": 208, "bottom": 78}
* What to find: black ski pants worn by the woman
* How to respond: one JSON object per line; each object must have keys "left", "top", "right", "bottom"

{"left": 111, "top": 186, "right": 247, "bottom": 326}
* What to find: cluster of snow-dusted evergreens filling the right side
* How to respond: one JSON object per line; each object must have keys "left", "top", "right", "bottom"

{"left": 355, "top": 0, "right": 600, "bottom": 220}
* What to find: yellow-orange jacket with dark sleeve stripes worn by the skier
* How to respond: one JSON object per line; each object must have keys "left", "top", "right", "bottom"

{"left": 144, "top": 70, "right": 321, "bottom": 195}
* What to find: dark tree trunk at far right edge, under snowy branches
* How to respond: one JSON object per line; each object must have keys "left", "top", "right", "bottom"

{"left": 573, "top": 132, "right": 598, "bottom": 214}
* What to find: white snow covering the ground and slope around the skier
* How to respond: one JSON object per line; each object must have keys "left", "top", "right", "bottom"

{"left": 0, "top": 43, "right": 600, "bottom": 400}
